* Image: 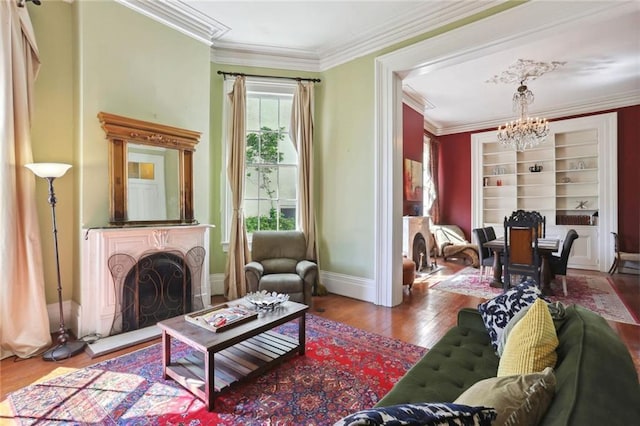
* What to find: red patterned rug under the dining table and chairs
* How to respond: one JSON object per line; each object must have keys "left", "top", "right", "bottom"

{"left": 431, "top": 267, "right": 640, "bottom": 324}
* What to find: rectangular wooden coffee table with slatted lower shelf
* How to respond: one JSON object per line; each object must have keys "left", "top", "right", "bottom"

{"left": 158, "top": 300, "right": 309, "bottom": 411}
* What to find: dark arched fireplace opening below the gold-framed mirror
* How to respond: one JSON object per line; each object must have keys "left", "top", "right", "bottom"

{"left": 122, "top": 252, "right": 191, "bottom": 332}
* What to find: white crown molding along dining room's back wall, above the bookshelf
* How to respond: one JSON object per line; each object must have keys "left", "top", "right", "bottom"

{"left": 425, "top": 89, "right": 640, "bottom": 136}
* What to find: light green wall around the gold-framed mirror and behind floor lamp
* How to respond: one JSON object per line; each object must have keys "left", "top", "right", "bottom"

{"left": 29, "top": 1, "right": 211, "bottom": 303}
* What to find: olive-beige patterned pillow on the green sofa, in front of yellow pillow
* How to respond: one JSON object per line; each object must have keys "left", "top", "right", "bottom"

{"left": 454, "top": 367, "right": 556, "bottom": 426}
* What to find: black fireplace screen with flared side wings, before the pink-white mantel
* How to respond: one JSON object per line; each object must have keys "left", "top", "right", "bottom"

{"left": 109, "top": 247, "right": 205, "bottom": 334}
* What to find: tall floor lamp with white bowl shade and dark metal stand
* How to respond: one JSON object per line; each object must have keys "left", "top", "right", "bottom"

{"left": 25, "top": 163, "right": 85, "bottom": 361}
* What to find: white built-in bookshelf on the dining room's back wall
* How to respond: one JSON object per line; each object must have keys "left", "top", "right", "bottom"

{"left": 471, "top": 113, "right": 617, "bottom": 270}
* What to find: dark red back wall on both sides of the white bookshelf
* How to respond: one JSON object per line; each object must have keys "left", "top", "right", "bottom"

{"left": 437, "top": 105, "right": 640, "bottom": 252}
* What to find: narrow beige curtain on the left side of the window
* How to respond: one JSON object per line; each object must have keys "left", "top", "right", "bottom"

{"left": 224, "top": 76, "right": 250, "bottom": 300}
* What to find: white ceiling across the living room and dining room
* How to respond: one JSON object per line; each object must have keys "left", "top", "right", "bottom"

{"left": 116, "top": 0, "right": 640, "bottom": 135}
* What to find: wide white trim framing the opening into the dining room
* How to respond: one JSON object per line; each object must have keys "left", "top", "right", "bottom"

{"left": 373, "top": 2, "right": 635, "bottom": 306}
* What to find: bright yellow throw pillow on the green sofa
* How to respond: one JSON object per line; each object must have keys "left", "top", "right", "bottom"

{"left": 498, "top": 299, "right": 559, "bottom": 377}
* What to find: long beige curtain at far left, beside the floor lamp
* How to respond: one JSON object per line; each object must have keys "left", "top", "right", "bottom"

{"left": 0, "top": 1, "right": 51, "bottom": 358}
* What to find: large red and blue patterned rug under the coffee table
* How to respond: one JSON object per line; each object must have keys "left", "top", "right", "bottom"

{"left": 5, "top": 314, "right": 427, "bottom": 426}
